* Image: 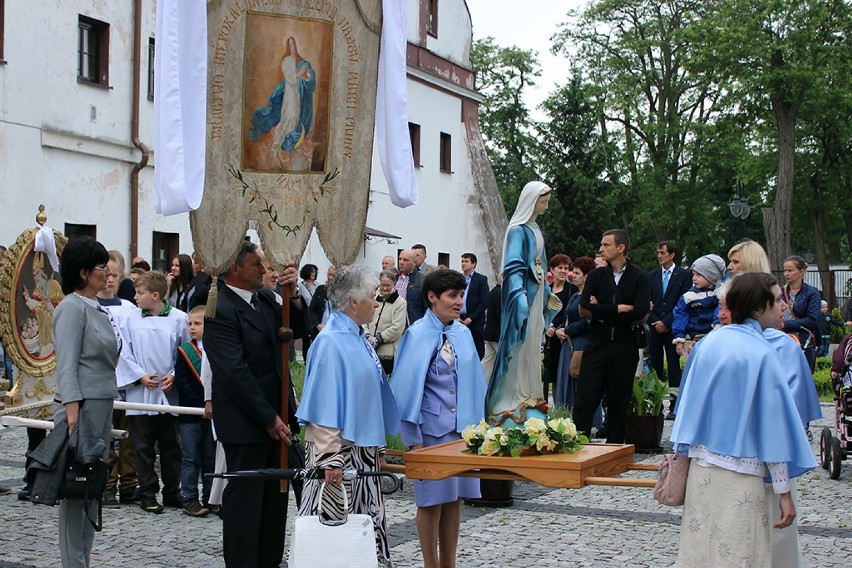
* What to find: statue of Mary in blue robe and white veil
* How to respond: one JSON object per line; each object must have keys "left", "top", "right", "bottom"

{"left": 485, "top": 181, "right": 562, "bottom": 425}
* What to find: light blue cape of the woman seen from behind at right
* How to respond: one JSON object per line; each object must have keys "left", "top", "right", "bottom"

{"left": 671, "top": 319, "right": 816, "bottom": 481}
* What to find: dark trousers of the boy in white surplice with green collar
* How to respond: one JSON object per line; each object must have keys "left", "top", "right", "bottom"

{"left": 128, "top": 414, "right": 183, "bottom": 502}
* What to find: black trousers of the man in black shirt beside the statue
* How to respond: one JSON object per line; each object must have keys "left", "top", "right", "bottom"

{"left": 574, "top": 341, "right": 639, "bottom": 444}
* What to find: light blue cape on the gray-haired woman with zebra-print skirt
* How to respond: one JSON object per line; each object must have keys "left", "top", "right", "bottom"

{"left": 296, "top": 311, "right": 399, "bottom": 446}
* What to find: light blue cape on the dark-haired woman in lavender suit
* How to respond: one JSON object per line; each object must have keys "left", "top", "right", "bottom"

{"left": 392, "top": 309, "right": 488, "bottom": 433}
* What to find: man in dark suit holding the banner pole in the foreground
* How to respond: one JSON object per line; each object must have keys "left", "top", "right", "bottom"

{"left": 204, "top": 241, "right": 303, "bottom": 568}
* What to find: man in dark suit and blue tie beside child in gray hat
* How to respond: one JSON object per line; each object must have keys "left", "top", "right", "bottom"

{"left": 648, "top": 241, "right": 692, "bottom": 420}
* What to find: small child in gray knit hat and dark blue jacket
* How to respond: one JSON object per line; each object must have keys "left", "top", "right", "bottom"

{"left": 672, "top": 254, "right": 725, "bottom": 356}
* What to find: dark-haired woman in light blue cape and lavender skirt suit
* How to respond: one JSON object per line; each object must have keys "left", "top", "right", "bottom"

{"left": 391, "top": 268, "right": 486, "bottom": 567}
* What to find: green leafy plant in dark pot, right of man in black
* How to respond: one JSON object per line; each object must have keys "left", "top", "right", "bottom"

{"left": 624, "top": 371, "right": 677, "bottom": 449}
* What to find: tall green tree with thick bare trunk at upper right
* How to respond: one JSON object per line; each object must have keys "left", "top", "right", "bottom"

{"left": 688, "top": 0, "right": 849, "bottom": 269}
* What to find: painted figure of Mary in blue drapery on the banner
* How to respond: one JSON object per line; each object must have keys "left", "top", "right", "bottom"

{"left": 249, "top": 37, "right": 317, "bottom": 171}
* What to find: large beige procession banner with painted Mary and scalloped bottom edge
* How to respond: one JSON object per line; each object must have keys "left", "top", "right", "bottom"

{"left": 195, "top": 0, "right": 382, "bottom": 273}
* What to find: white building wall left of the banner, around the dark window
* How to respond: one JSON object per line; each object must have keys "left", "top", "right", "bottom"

{"left": 0, "top": 0, "right": 192, "bottom": 258}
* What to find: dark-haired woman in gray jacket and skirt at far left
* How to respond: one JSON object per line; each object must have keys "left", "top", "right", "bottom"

{"left": 53, "top": 237, "right": 121, "bottom": 568}
